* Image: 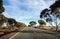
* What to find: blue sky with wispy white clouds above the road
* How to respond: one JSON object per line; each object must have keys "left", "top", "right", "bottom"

{"left": 3, "top": 0, "right": 55, "bottom": 25}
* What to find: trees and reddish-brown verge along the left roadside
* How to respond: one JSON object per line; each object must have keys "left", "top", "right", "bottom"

{"left": 0, "top": 0, "right": 26, "bottom": 39}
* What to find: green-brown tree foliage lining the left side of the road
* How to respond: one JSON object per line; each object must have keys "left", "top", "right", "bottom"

{"left": 0, "top": 0, "right": 26, "bottom": 29}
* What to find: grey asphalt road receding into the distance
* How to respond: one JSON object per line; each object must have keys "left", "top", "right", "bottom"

{"left": 10, "top": 27, "right": 60, "bottom": 39}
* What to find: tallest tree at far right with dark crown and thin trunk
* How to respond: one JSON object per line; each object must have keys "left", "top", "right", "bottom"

{"left": 50, "top": 0, "right": 60, "bottom": 31}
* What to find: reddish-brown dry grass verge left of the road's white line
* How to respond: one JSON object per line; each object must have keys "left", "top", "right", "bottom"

{"left": 0, "top": 27, "right": 24, "bottom": 39}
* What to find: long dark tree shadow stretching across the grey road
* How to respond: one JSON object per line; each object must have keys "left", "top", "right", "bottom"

{"left": 19, "top": 30, "right": 60, "bottom": 38}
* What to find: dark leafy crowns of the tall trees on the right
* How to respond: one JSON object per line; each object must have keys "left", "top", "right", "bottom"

{"left": 40, "top": 0, "right": 60, "bottom": 30}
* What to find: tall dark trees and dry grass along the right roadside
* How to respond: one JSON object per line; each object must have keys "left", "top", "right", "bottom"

{"left": 29, "top": 0, "right": 60, "bottom": 32}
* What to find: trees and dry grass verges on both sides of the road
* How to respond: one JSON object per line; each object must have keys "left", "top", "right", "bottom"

{"left": 0, "top": 0, "right": 60, "bottom": 38}
